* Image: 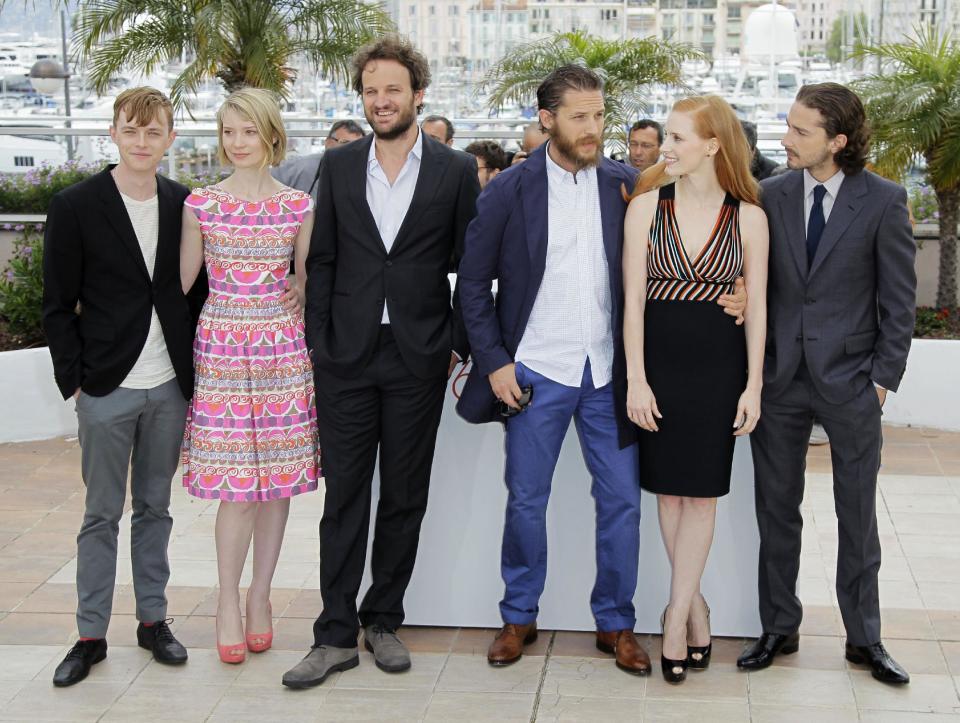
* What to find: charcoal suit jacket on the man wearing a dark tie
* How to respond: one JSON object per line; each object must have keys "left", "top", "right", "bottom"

{"left": 761, "top": 171, "right": 917, "bottom": 404}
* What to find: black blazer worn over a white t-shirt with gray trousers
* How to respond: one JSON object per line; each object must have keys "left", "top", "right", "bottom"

{"left": 43, "top": 166, "right": 206, "bottom": 399}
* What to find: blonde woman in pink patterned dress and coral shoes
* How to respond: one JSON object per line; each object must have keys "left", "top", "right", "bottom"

{"left": 180, "top": 88, "right": 320, "bottom": 663}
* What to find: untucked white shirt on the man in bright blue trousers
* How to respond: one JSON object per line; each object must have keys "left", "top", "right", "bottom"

{"left": 516, "top": 148, "right": 613, "bottom": 389}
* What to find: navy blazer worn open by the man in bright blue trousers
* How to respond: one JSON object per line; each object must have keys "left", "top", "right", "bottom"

{"left": 457, "top": 144, "right": 637, "bottom": 446}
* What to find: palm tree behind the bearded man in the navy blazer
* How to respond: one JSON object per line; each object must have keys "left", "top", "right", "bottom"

{"left": 480, "top": 30, "right": 704, "bottom": 145}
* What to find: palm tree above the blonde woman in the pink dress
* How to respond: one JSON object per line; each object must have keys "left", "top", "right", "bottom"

{"left": 73, "top": 0, "right": 392, "bottom": 108}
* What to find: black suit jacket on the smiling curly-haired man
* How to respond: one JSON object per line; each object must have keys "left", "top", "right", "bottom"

{"left": 306, "top": 134, "right": 480, "bottom": 379}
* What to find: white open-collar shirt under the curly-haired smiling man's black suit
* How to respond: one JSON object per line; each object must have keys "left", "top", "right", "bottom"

{"left": 367, "top": 128, "right": 423, "bottom": 324}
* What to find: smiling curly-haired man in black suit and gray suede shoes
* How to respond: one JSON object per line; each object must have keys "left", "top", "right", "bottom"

{"left": 283, "top": 36, "right": 480, "bottom": 688}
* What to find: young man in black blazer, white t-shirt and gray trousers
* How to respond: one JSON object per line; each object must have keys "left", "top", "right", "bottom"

{"left": 43, "top": 88, "right": 195, "bottom": 686}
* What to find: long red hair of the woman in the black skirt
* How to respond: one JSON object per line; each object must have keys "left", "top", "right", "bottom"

{"left": 628, "top": 95, "right": 760, "bottom": 205}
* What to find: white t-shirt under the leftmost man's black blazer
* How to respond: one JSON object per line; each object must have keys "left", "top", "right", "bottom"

{"left": 120, "top": 193, "right": 177, "bottom": 389}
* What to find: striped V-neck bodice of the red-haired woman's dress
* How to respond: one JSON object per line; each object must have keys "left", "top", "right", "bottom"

{"left": 647, "top": 183, "right": 743, "bottom": 301}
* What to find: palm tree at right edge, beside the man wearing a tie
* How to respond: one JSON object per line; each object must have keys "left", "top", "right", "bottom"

{"left": 857, "top": 28, "right": 960, "bottom": 309}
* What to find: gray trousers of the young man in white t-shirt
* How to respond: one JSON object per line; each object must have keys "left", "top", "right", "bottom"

{"left": 76, "top": 379, "right": 187, "bottom": 638}
